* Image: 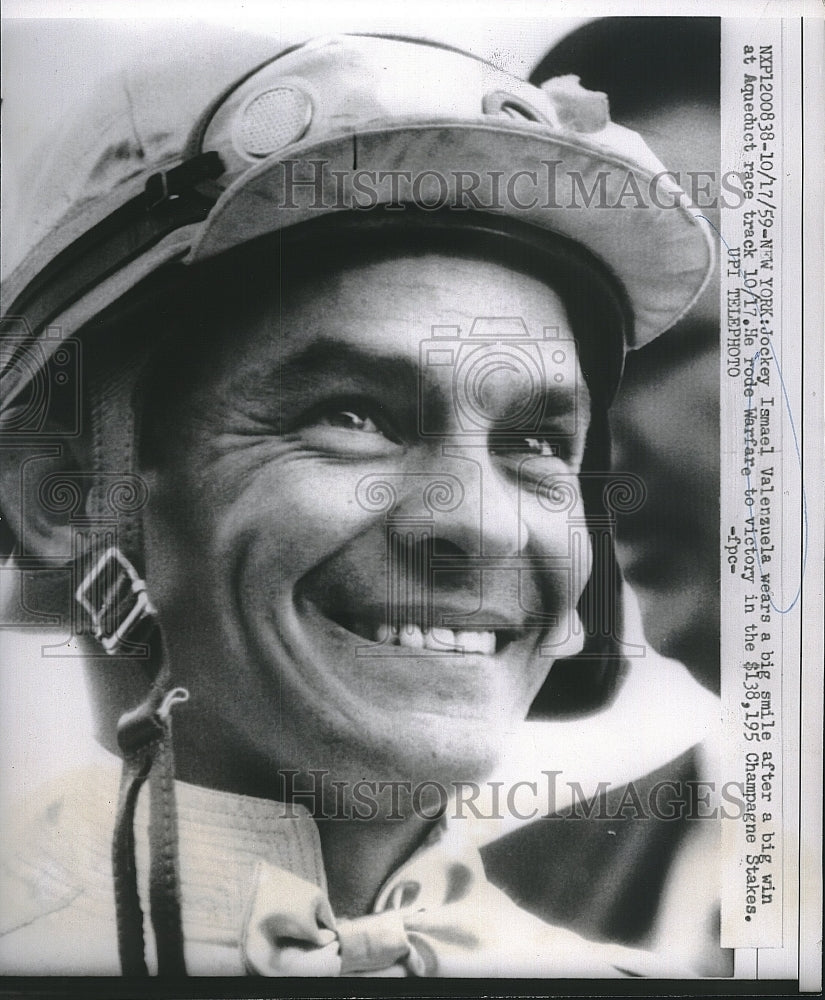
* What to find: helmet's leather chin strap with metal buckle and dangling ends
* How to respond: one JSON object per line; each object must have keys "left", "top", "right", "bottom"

{"left": 75, "top": 356, "right": 189, "bottom": 976}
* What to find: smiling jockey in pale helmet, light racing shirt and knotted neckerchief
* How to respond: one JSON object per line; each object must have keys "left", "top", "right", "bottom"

{"left": 2, "top": 29, "right": 711, "bottom": 976}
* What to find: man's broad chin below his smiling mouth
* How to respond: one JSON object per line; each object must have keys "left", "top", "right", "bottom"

{"left": 238, "top": 607, "right": 549, "bottom": 785}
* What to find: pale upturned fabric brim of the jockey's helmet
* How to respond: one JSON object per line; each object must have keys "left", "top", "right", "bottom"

{"left": 192, "top": 119, "right": 713, "bottom": 348}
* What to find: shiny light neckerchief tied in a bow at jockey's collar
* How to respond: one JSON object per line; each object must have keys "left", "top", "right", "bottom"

{"left": 241, "top": 824, "right": 690, "bottom": 978}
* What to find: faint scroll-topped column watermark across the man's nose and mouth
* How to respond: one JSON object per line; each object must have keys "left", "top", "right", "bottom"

{"left": 356, "top": 464, "right": 646, "bottom": 659}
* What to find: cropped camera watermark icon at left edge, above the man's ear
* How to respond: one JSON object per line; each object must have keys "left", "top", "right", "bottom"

{"left": 0, "top": 316, "right": 82, "bottom": 440}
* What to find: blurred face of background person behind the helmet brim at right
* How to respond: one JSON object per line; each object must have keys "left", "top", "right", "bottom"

{"left": 611, "top": 101, "right": 719, "bottom": 689}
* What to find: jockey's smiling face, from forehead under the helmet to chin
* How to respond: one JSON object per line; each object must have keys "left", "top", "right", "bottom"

{"left": 147, "top": 253, "right": 590, "bottom": 795}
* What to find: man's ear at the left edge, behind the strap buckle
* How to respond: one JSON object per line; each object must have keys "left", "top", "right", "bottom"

{"left": 0, "top": 437, "right": 93, "bottom": 565}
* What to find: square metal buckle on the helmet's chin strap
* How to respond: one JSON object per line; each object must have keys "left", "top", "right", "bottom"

{"left": 75, "top": 546, "right": 157, "bottom": 656}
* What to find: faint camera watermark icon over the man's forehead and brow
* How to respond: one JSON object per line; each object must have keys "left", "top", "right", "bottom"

{"left": 418, "top": 316, "right": 579, "bottom": 444}
